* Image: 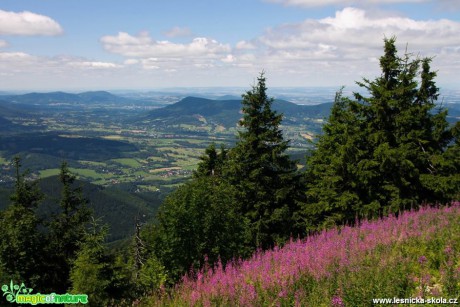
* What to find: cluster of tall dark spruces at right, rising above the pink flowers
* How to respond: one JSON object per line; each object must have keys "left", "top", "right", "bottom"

{"left": 305, "top": 38, "right": 460, "bottom": 226}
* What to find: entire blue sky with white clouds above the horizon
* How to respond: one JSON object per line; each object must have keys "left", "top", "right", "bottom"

{"left": 0, "top": 0, "right": 460, "bottom": 91}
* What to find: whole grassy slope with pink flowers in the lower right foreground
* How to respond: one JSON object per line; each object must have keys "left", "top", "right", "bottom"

{"left": 144, "top": 202, "right": 460, "bottom": 306}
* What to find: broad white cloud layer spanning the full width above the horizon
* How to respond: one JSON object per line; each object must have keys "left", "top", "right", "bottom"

{"left": 0, "top": 5, "right": 460, "bottom": 88}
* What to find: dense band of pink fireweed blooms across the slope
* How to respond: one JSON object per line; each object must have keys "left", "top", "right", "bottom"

{"left": 175, "top": 202, "right": 460, "bottom": 306}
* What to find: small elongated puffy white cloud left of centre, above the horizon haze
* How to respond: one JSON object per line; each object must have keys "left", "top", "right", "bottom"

{"left": 101, "top": 32, "right": 231, "bottom": 58}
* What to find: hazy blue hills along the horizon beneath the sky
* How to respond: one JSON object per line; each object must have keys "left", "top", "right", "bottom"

{"left": 0, "top": 91, "right": 460, "bottom": 130}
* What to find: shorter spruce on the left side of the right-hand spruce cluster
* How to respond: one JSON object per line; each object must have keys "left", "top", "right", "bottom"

{"left": 304, "top": 90, "right": 367, "bottom": 230}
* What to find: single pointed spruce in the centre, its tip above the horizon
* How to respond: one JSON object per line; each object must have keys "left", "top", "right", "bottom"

{"left": 225, "top": 73, "right": 300, "bottom": 249}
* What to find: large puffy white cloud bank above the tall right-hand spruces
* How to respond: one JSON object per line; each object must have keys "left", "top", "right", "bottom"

{"left": 260, "top": 8, "right": 460, "bottom": 55}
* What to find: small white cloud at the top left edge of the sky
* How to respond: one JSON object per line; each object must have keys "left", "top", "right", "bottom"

{"left": 0, "top": 10, "right": 63, "bottom": 35}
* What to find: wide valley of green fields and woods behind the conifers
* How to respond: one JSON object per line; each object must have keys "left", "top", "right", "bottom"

{"left": 0, "top": 94, "right": 326, "bottom": 192}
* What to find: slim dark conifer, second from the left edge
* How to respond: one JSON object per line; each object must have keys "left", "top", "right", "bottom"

{"left": 47, "top": 162, "right": 91, "bottom": 293}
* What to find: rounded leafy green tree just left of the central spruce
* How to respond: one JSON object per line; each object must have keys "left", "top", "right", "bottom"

{"left": 148, "top": 177, "right": 248, "bottom": 281}
